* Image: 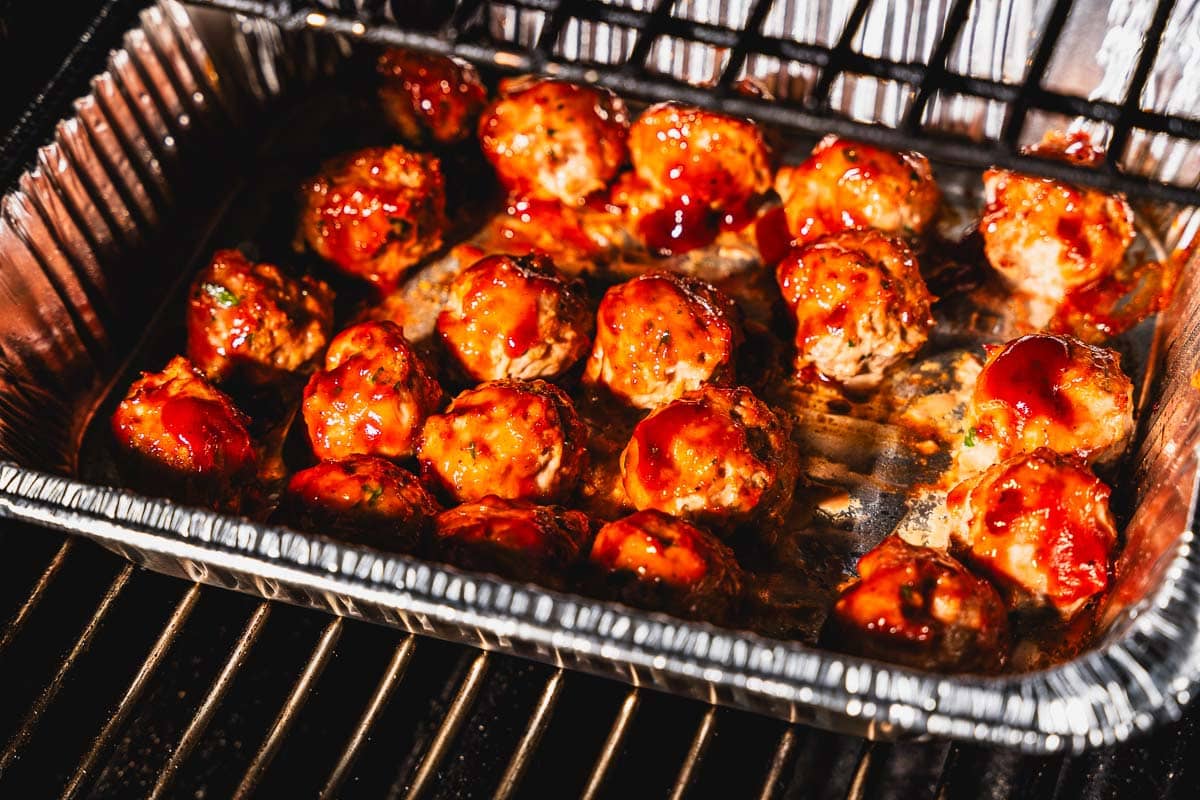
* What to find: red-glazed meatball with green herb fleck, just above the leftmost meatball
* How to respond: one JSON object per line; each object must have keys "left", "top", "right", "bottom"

{"left": 187, "top": 249, "right": 334, "bottom": 383}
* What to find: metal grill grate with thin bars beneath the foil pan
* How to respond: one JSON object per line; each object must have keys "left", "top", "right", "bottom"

{"left": 0, "top": 527, "right": 1200, "bottom": 799}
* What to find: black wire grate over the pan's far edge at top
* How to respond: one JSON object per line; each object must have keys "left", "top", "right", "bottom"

{"left": 189, "top": 0, "right": 1200, "bottom": 205}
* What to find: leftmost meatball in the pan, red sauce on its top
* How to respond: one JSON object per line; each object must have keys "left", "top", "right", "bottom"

{"left": 113, "top": 356, "right": 258, "bottom": 510}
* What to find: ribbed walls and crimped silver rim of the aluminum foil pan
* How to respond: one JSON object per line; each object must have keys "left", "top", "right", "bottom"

{"left": 0, "top": 0, "right": 1200, "bottom": 752}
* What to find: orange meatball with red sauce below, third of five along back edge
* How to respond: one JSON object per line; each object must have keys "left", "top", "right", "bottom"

{"left": 629, "top": 103, "right": 770, "bottom": 212}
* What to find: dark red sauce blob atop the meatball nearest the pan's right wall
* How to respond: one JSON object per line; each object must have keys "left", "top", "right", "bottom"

{"left": 980, "top": 335, "right": 1074, "bottom": 425}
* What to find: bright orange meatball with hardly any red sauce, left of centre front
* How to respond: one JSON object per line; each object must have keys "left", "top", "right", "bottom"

{"left": 418, "top": 380, "right": 587, "bottom": 503}
